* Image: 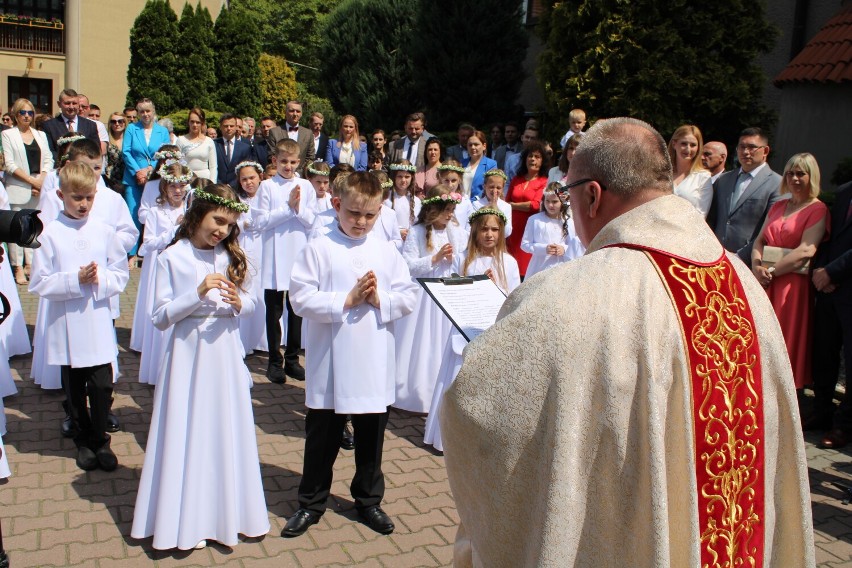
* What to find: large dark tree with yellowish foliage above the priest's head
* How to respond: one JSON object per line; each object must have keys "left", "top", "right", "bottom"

{"left": 538, "top": 0, "right": 777, "bottom": 146}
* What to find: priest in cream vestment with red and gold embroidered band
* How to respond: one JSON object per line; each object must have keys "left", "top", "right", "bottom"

{"left": 441, "top": 119, "right": 814, "bottom": 568}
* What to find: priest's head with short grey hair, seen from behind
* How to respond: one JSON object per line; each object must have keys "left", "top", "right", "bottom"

{"left": 566, "top": 117, "right": 672, "bottom": 247}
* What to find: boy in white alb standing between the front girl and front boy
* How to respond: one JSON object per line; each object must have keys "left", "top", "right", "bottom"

{"left": 255, "top": 138, "right": 316, "bottom": 383}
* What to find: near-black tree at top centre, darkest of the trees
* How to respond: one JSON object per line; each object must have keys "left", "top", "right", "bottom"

{"left": 412, "top": 0, "right": 528, "bottom": 132}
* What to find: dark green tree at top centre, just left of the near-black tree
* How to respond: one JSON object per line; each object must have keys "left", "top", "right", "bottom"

{"left": 319, "top": 0, "right": 420, "bottom": 132}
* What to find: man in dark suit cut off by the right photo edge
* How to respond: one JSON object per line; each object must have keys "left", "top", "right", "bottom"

{"left": 802, "top": 182, "right": 852, "bottom": 449}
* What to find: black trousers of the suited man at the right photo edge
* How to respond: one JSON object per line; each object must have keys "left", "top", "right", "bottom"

{"left": 811, "top": 293, "right": 852, "bottom": 432}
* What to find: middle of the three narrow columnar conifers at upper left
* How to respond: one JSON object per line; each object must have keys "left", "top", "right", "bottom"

{"left": 173, "top": 3, "right": 216, "bottom": 109}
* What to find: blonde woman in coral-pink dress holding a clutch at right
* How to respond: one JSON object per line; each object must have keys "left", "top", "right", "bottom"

{"left": 751, "top": 153, "right": 830, "bottom": 389}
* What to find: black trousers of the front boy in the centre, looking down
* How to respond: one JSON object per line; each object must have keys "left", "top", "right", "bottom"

{"left": 299, "top": 409, "right": 388, "bottom": 514}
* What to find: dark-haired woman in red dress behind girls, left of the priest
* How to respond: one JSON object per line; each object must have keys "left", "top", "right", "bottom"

{"left": 506, "top": 140, "right": 550, "bottom": 278}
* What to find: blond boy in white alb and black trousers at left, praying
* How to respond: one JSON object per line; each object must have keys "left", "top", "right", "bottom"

{"left": 29, "top": 162, "right": 130, "bottom": 471}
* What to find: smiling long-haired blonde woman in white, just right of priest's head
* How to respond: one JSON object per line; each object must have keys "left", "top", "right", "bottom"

{"left": 669, "top": 124, "right": 713, "bottom": 217}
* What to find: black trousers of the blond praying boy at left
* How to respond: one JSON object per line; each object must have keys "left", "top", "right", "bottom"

{"left": 60, "top": 363, "right": 112, "bottom": 451}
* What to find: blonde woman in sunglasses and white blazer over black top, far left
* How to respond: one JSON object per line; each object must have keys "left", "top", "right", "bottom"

{"left": 2, "top": 99, "right": 53, "bottom": 284}
